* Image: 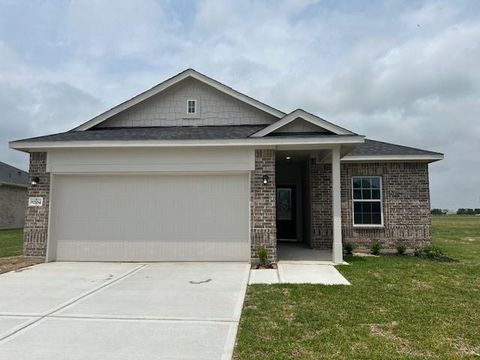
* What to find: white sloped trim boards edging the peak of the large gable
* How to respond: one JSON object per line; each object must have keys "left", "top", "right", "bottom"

{"left": 74, "top": 69, "right": 285, "bottom": 131}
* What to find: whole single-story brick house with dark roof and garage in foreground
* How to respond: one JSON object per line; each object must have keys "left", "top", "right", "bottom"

{"left": 10, "top": 69, "right": 443, "bottom": 263}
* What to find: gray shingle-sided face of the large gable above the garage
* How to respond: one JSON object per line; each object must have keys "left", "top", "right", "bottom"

{"left": 96, "top": 78, "right": 278, "bottom": 128}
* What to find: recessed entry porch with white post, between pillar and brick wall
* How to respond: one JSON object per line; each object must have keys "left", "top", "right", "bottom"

{"left": 275, "top": 147, "right": 343, "bottom": 264}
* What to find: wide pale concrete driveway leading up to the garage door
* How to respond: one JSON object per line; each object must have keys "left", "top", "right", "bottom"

{"left": 0, "top": 262, "right": 249, "bottom": 360}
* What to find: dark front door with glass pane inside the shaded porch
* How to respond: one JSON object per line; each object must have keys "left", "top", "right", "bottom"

{"left": 277, "top": 185, "right": 297, "bottom": 240}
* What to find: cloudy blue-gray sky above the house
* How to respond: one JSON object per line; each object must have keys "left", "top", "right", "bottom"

{"left": 0, "top": 0, "right": 480, "bottom": 209}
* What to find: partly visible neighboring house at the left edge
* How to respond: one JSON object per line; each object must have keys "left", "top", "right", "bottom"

{"left": 0, "top": 161, "right": 28, "bottom": 229}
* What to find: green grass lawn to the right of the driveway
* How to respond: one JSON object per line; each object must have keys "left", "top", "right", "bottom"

{"left": 235, "top": 216, "right": 480, "bottom": 359}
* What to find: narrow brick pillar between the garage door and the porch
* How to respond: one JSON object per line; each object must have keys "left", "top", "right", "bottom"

{"left": 250, "top": 150, "right": 277, "bottom": 261}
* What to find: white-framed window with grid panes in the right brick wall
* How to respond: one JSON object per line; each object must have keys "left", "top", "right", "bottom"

{"left": 352, "top": 176, "right": 383, "bottom": 226}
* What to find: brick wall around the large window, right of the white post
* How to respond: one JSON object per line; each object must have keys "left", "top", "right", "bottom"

{"left": 342, "top": 162, "right": 432, "bottom": 249}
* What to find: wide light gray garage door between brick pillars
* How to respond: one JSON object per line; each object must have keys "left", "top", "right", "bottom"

{"left": 49, "top": 174, "right": 250, "bottom": 261}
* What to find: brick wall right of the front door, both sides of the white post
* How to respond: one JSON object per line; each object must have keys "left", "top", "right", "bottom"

{"left": 310, "top": 162, "right": 432, "bottom": 249}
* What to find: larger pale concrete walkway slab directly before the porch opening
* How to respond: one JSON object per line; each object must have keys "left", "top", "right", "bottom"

{"left": 278, "top": 263, "right": 350, "bottom": 285}
